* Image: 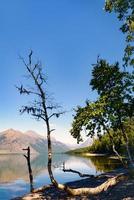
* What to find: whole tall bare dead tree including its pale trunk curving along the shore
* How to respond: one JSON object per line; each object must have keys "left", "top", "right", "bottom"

{"left": 17, "top": 51, "right": 126, "bottom": 195}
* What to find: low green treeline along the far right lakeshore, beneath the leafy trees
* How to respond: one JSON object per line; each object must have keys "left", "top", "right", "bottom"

{"left": 68, "top": 120, "right": 134, "bottom": 156}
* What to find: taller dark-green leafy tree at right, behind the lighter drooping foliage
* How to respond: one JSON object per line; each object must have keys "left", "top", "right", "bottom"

{"left": 90, "top": 60, "right": 134, "bottom": 163}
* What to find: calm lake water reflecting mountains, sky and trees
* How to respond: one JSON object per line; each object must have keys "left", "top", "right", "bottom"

{"left": 0, "top": 154, "right": 120, "bottom": 200}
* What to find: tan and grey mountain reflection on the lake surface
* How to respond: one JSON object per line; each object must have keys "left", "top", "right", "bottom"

{"left": 0, "top": 154, "right": 67, "bottom": 183}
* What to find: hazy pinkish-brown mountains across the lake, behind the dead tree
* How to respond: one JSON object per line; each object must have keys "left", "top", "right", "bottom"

{"left": 0, "top": 129, "right": 69, "bottom": 154}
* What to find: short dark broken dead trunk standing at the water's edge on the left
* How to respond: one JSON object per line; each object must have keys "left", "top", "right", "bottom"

{"left": 23, "top": 147, "right": 34, "bottom": 192}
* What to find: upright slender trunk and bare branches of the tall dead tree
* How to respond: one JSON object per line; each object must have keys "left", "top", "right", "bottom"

{"left": 16, "top": 51, "right": 64, "bottom": 188}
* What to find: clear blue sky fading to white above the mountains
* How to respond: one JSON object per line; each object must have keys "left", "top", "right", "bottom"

{"left": 0, "top": 0, "right": 124, "bottom": 143}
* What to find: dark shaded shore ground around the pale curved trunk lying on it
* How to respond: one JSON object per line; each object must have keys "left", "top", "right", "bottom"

{"left": 12, "top": 168, "right": 134, "bottom": 200}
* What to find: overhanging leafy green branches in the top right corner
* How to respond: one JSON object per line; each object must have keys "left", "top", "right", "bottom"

{"left": 105, "top": 0, "right": 134, "bottom": 66}
